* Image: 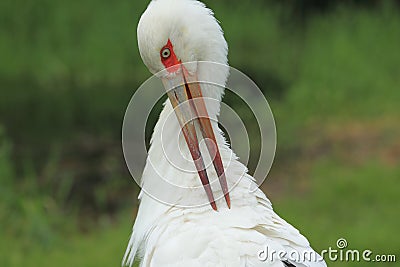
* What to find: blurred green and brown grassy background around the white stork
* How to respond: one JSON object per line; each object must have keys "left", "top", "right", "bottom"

{"left": 0, "top": 0, "right": 400, "bottom": 267}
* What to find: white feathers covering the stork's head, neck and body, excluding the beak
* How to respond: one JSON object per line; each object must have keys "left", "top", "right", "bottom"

{"left": 123, "top": 0, "right": 326, "bottom": 267}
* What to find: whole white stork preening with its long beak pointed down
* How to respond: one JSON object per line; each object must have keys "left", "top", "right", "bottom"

{"left": 123, "top": 0, "right": 326, "bottom": 267}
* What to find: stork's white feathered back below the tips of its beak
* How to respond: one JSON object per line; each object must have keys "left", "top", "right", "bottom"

{"left": 124, "top": 175, "right": 326, "bottom": 267}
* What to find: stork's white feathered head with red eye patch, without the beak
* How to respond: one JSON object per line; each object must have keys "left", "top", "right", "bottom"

{"left": 137, "top": 0, "right": 228, "bottom": 74}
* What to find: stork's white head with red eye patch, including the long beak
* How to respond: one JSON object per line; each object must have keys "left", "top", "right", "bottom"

{"left": 138, "top": 0, "right": 230, "bottom": 213}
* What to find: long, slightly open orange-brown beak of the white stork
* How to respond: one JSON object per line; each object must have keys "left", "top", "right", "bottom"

{"left": 163, "top": 65, "right": 231, "bottom": 210}
